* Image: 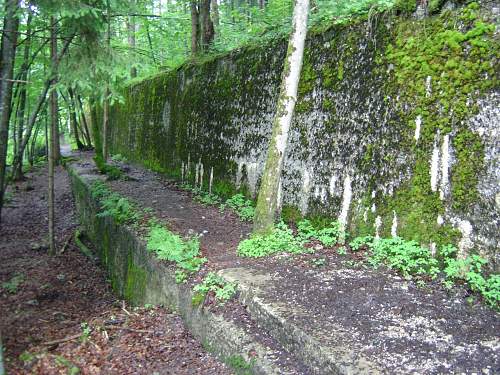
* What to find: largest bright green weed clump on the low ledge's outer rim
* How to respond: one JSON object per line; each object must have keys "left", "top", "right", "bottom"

{"left": 146, "top": 224, "right": 207, "bottom": 283}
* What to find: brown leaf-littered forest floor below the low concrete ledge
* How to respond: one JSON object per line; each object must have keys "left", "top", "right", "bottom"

{"left": 0, "top": 167, "right": 230, "bottom": 374}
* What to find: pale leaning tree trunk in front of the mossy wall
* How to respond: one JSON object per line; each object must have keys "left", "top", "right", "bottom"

{"left": 254, "top": 0, "right": 309, "bottom": 234}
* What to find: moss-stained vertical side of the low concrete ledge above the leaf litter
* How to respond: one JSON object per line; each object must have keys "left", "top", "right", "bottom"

{"left": 66, "top": 164, "right": 292, "bottom": 374}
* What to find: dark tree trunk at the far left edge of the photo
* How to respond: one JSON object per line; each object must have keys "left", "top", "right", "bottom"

{"left": 0, "top": 0, "right": 19, "bottom": 221}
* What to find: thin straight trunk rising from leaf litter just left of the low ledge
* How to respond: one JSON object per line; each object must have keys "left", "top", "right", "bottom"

{"left": 48, "top": 17, "right": 59, "bottom": 255}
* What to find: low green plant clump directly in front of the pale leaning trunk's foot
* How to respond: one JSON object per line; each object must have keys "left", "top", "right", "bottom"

{"left": 237, "top": 222, "right": 306, "bottom": 258}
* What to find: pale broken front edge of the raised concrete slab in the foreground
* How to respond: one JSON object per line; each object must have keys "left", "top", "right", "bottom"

{"left": 219, "top": 268, "right": 384, "bottom": 374}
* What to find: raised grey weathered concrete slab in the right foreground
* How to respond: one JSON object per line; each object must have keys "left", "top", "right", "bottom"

{"left": 219, "top": 266, "right": 500, "bottom": 374}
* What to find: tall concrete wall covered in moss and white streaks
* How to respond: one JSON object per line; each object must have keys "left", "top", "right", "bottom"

{"left": 110, "top": 2, "right": 500, "bottom": 268}
